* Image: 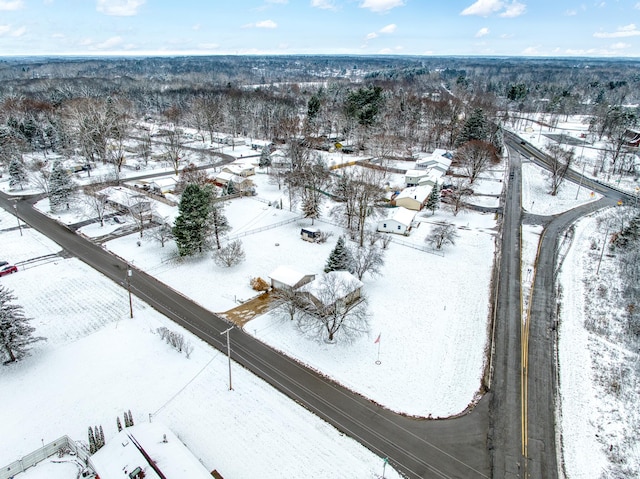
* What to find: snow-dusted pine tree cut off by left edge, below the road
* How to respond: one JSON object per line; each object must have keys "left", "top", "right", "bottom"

{"left": 0, "top": 286, "right": 45, "bottom": 363}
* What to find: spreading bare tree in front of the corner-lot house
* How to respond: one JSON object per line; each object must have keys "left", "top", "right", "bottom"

{"left": 296, "top": 272, "right": 369, "bottom": 341}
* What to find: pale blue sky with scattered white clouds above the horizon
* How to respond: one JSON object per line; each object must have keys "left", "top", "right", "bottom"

{"left": 0, "top": 0, "right": 640, "bottom": 57}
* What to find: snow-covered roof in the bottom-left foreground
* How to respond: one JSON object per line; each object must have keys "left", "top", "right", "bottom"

{"left": 91, "top": 422, "right": 211, "bottom": 479}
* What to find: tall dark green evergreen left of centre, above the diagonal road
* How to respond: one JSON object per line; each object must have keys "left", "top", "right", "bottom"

{"left": 173, "top": 184, "right": 213, "bottom": 256}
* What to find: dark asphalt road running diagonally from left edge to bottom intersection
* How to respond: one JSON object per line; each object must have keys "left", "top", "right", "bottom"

{"left": 0, "top": 195, "right": 490, "bottom": 479}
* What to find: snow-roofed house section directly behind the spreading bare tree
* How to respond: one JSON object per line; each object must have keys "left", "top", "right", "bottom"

{"left": 300, "top": 271, "right": 364, "bottom": 309}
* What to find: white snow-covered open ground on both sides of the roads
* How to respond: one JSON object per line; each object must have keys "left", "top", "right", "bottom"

{"left": 0, "top": 117, "right": 636, "bottom": 479}
